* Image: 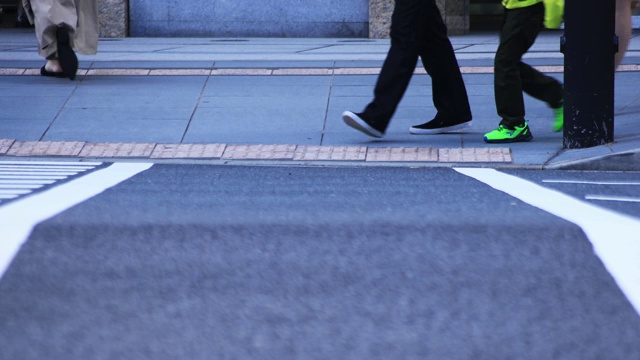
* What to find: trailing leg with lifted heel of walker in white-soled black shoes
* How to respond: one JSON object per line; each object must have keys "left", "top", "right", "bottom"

{"left": 342, "top": 0, "right": 422, "bottom": 137}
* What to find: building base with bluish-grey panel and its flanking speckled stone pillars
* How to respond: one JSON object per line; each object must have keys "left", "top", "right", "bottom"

{"left": 98, "top": 0, "right": 473, "bottom": 38}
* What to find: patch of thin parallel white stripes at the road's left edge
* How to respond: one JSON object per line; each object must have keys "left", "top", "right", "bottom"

{"left": 0, "top": 161, "right": 102, "bottom": 205}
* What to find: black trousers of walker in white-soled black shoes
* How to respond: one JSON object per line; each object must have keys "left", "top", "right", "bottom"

{"left": 362, "top": 0, "right": 471, "bottom": 129}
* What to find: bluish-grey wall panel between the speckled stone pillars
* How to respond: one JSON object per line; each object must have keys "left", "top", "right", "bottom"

{"left": 129, "top": 0, "right": 369, "bottom": 37}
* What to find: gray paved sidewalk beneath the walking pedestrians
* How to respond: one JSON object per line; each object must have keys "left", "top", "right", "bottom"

{"left": 0, "top": 29, "right": 640, "bottom": 169}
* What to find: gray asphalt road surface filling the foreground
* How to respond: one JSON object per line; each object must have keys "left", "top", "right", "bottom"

{"left": 0, "top": 164, "right": 640, "bottom": 360}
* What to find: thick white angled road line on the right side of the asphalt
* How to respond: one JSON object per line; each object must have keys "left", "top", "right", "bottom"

{"left": 455, "top": 168, "right": 640, "bottom": 315}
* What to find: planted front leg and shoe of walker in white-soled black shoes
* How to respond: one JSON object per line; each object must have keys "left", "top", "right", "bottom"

{"left": 409, "top": 0, "right": 471, "bottom": 135}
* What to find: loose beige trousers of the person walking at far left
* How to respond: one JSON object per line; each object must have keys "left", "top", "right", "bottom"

{"left": 22, "top": 0, "right": 98, "bottom": 58}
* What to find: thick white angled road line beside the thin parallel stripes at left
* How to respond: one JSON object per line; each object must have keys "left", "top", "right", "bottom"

{"left": 0, "top": 163, "right": 153, "bottom": 278}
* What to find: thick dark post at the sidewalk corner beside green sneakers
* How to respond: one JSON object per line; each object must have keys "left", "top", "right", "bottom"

{"left": 561, "top": 0, "right": 618, "bottom": 149}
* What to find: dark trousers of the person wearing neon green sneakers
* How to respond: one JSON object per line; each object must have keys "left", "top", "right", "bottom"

{"left": 494, "top": 3, "right": 563, "bottom": 129}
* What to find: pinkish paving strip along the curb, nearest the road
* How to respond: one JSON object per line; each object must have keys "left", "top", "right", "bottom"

{"left": 0, "top": 139, "right": 512, "bottom": 163}
